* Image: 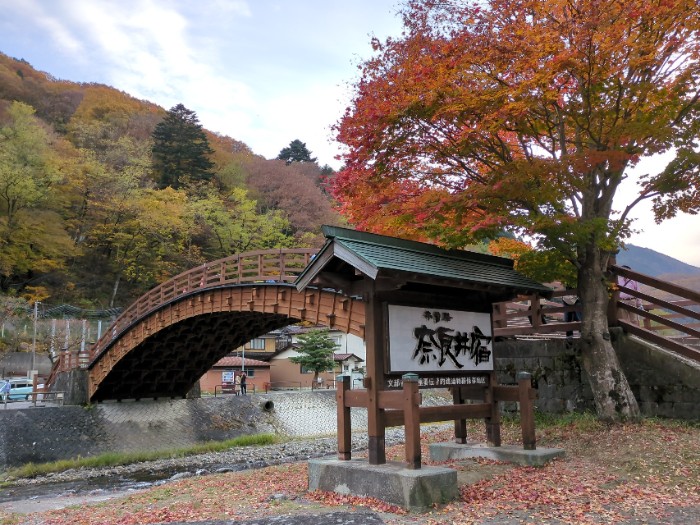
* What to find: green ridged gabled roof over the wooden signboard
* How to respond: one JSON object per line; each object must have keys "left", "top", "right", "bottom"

{"left": 295, "top": 226, "right": 552, "bottom": 296}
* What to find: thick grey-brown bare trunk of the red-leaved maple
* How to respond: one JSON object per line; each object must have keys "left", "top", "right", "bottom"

{"left": 578, "top": 248, "right": 639, "bottom": 421}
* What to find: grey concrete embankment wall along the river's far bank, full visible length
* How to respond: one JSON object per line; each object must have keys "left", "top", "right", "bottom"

{"left": 0, "top": 390, "right": 454, "bottom": 469}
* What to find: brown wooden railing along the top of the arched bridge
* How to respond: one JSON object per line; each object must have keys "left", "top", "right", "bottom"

{"left": 90, "top": 248, "right": 317, "bottom": 360}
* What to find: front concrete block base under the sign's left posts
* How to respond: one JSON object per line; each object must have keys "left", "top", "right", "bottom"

{"left": 308, "top": 458, "right": 459, "bottom": 512}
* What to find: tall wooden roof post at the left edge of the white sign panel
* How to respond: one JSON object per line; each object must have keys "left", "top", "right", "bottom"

{"left": 365, "top": 281, "right": 386, "bottom": 465}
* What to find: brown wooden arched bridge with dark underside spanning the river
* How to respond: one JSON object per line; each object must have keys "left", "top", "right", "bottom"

{"left": 49, "top": 249, "right": 365, "bottom": 401}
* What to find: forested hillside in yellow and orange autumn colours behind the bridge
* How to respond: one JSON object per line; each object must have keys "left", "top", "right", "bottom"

{"left": 0, "top": 54, "right": 339, "bottom": 308}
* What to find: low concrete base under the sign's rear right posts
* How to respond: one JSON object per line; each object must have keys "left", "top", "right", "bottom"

{"left": 429, "top": 443, "right": 564, "bottom": 467}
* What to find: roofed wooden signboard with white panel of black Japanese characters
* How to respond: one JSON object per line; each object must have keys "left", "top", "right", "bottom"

{"left": 295, "top": 226, "right": 551, "bottom": 469}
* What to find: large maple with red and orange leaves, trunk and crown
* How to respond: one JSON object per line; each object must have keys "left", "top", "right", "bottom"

{"left": 334, "top": 0, "right": 700, "bottom": 419}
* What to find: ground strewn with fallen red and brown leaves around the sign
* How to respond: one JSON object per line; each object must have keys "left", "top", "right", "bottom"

{"left": 8, "top": 421, "right": 700, "bottom": 525}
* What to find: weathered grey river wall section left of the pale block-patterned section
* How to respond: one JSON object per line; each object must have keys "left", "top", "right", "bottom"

{"left": 0, "top": 396, "right": 276, "bottom": 469}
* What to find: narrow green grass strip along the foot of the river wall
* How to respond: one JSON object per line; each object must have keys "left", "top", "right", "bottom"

{"left": 3, "top": 434, "right": 280, "bottom": 481}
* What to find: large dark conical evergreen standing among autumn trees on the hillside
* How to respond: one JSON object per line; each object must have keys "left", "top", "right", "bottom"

{"left": 152, "top": 104, "right": 214, "bottom": 189}
